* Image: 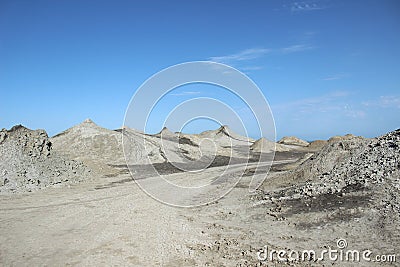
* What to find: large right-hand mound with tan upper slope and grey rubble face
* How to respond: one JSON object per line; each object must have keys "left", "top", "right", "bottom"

{"left": 264, "top": 129, "right": 400, "bottom": 215}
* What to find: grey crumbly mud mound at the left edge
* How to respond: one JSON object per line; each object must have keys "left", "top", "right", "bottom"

{"left": 0, "top": 125, "right": 90, "bottom": 193}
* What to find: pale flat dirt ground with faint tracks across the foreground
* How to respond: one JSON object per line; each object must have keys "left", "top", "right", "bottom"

{"left": 0, "top": 155, "right": 400, "bottom": 266}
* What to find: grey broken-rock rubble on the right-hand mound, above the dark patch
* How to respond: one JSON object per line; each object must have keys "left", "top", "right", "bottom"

{"left": 297, "top": 129, "right": 400, "bottom": 199}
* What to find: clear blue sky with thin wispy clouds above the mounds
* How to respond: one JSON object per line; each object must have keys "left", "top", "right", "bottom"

{"left": 0, "top": 0, "right": 400, "bottom": 140}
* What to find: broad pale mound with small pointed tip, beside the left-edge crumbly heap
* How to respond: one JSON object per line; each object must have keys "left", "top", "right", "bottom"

{"left": 51, "top": 119, "right": 163, "bottom": 176}
